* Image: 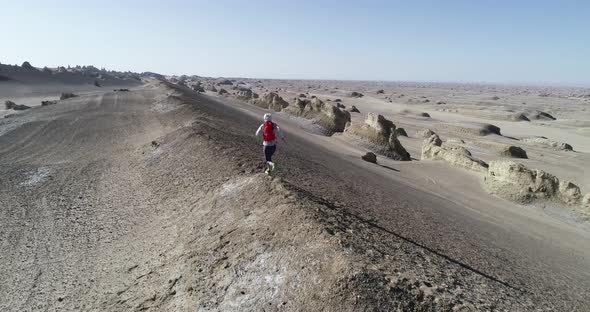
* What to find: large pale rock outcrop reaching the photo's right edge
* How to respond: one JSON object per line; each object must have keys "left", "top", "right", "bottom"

{"left": 484, "top": 160, "right": 590, "bottom": 215}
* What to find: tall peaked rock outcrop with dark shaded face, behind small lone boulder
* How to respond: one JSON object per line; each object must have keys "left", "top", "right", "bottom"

{"left": 344, "top": 113, "right": 411, "bottom": 161}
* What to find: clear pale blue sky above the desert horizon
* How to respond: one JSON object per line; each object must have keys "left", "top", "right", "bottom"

{"left": 0, "top": 0, "right": 590, "bottom": 87}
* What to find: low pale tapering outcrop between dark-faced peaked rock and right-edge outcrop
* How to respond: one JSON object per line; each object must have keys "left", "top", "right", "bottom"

{"left": 422, "top": 134, "right": 488, "bottom": 173}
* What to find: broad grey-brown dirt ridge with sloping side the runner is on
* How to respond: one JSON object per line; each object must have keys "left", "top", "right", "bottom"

{"left": 0, "top": 84, "right": 590, "bottom": 311}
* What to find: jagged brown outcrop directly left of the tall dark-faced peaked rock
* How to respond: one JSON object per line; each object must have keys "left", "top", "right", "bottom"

{"left": 287, "top": 97, "right": 350, "bottom": 132}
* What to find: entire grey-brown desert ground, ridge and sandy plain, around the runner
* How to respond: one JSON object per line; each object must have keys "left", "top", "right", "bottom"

{"left": 0, "top": 63, "right": 590, "bottom": 311}
